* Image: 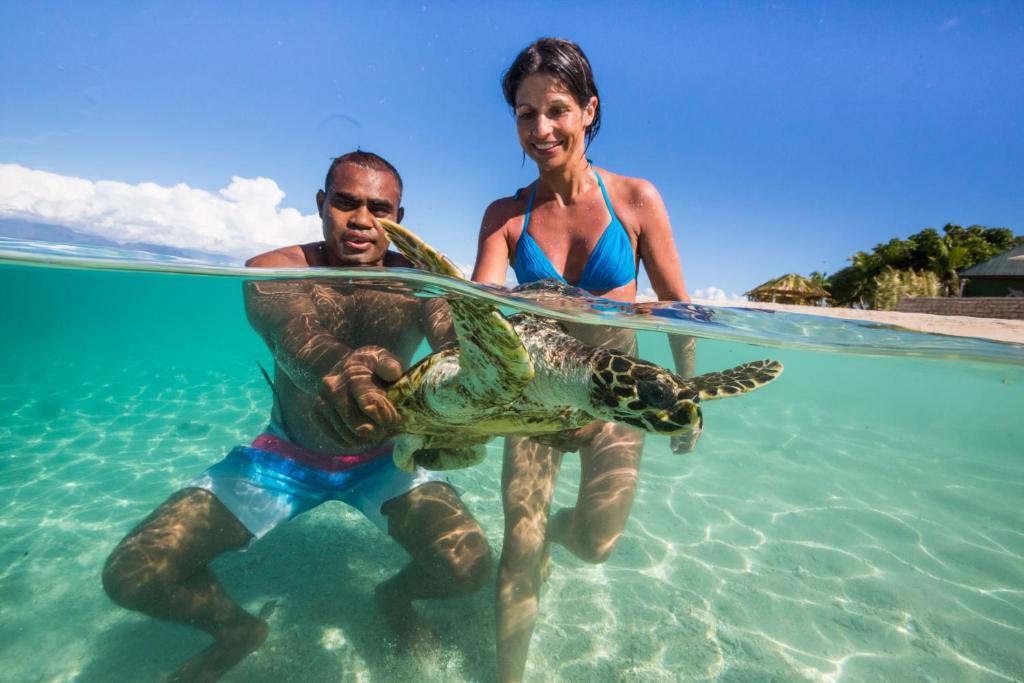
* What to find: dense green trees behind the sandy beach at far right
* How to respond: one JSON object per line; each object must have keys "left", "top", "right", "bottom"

{"left": 814, "top": 223, "right": 1024, "bottom": 307}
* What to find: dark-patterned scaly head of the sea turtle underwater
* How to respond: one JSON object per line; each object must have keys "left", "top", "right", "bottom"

{"left": 589, "top": 349, "right": 703, "bottom": 436}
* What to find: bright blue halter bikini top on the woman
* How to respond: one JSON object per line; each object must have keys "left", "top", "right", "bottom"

{"left": 512, "top": 171, "right": 637, "bottom": 292}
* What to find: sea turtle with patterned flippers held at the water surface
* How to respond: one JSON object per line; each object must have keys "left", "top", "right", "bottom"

{"left": 378, "top": 218, "right": 782, "bottom": 471}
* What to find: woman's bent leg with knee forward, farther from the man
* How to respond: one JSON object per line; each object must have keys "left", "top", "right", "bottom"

{"left": 548, "top": 422, "right": 644, "bottom": 563}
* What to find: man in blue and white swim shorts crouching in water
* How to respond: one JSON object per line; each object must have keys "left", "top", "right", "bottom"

{"left": 103, "top": 152, "right": 490, "bottom": 680}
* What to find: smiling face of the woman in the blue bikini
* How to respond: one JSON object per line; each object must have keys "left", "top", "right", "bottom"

{"left": 515, "top": 74, "right": 597, "bottom": 170}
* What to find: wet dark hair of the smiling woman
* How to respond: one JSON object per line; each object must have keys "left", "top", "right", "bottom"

{"left": 502, "top": 38, "right": 601, "bottom": 145}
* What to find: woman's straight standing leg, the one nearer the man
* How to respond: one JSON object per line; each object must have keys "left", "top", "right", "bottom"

{"left": 497, "top": 437, "right": 562, "bottom": 683}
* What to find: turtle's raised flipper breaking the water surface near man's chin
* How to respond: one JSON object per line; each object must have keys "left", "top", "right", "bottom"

{"left": 378, "top": 218, "right": 534, "bottom": 411}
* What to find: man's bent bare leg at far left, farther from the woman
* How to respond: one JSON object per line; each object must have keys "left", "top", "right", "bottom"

{"left": 103, "top": 488, "right": 267, "bottom": 681}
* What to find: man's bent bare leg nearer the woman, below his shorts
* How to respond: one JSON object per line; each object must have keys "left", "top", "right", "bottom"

{"left": 377, "top": 481, "right": 490, "bottom": 647}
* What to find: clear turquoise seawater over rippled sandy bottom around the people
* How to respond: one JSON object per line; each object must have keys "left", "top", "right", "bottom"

{"left": 0, "top": 243, "right": 1024, "bottom": 682}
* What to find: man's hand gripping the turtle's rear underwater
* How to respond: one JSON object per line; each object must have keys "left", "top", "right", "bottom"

{"left": 313, "top": 346, "right": 402, "bottom": 445}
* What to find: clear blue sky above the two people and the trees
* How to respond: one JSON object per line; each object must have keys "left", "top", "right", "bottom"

{"left": 0, "top": 1, "right": 1024, "bottom": 294}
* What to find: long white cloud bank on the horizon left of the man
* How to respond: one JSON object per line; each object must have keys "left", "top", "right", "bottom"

{"left": 0, "top": 164, "right": 321, "bottom": 259}
